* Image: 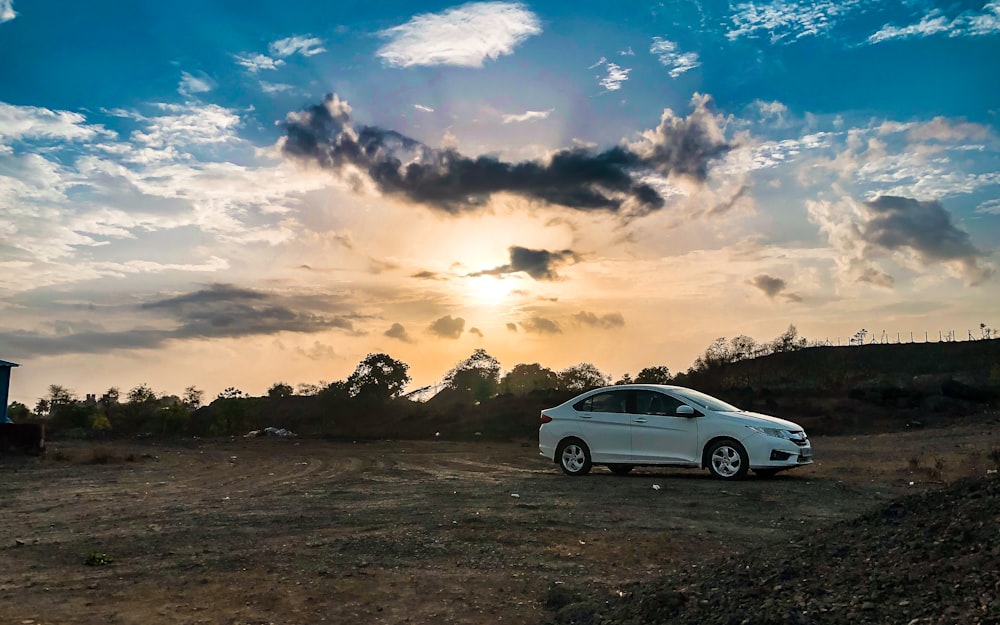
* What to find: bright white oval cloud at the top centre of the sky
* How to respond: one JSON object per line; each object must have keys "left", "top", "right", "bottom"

{"left": 376, "top": 2, "right": 542, "bottom": 67}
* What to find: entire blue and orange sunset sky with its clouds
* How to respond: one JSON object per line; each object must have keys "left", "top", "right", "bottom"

{"left": 0, "top": 0, "right": 1000, "bottom": 406}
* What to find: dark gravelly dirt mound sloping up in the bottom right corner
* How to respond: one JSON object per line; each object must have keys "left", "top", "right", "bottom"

{"left": 547, "top": 476, "right": 1000, "bottom": 625}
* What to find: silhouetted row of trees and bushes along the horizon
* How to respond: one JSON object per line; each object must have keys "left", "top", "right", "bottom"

{"left": 8, "top": 326, "right": 810, "bottom": 435}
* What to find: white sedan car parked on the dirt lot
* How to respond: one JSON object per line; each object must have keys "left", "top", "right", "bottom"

{"left": 538, "top": 384, "right": 813, "bottom": 480}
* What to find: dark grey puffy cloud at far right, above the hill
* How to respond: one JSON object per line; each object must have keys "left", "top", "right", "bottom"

{"left": 858, "top": 195, "right": 993, "bottom": 284}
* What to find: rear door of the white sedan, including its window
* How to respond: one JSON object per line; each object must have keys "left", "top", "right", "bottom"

{"left": 573, "top": 390, "right": 632, "bottom": 463}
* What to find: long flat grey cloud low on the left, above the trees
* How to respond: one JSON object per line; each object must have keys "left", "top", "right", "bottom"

{"left": 0, "top": 284, "right": 354, "bottom": 356}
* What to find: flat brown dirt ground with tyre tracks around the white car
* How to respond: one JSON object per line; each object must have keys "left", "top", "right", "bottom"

{"left": 0, "top": 417, "right": 1000, "bottom": 625}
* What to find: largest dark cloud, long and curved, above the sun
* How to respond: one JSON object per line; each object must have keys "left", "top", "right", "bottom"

{"left": 281, "top": 94, "right": 733, "bottom": 215}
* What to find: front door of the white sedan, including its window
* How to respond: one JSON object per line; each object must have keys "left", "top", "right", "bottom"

{"left": 630, "top": 390, "right": 700, "bottom": 464}
